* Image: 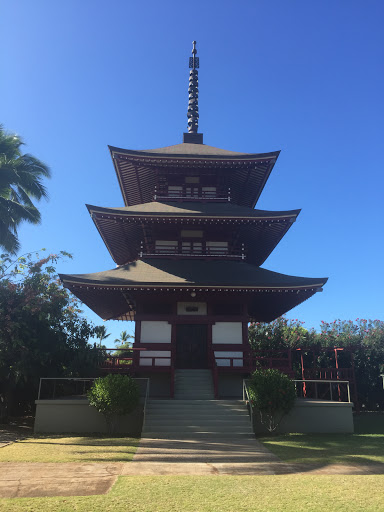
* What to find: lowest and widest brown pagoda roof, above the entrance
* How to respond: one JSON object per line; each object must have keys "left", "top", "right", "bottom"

{"left": 60, "top": 259, "right": 327, "bottom": 322}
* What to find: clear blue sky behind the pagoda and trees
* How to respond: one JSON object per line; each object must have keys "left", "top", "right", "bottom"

{"left": 0, "top": 0, "right": 384, "bottom": 339}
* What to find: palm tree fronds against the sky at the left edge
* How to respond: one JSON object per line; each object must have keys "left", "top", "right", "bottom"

{"left": 0, "top": 125, "right": 51, "bottom": 254}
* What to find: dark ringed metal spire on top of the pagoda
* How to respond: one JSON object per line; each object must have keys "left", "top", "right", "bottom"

{"left": 184, "top": 41, "right": 203, "bottom": 144}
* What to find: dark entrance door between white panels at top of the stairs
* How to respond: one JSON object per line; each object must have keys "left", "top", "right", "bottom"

{"left": 176, "top": 324, "right": 208, "bottom": 368}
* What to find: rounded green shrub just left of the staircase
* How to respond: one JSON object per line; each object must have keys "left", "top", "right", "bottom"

{"left": 88, "top": 374, "right": 140, "bottom": 434}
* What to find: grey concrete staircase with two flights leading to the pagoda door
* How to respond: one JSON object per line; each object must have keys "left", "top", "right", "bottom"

{"left": 142, "top": 370, "right": 254, "bottom": 440}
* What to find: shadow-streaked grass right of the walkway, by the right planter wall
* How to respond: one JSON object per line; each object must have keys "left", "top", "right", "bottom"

{"left": 259, "top": 413, "right": 384, "bottom": 468}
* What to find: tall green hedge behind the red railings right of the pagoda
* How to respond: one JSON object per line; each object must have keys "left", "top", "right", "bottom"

{"left": 249, "top": 317, "right": 384, "bottom": 410}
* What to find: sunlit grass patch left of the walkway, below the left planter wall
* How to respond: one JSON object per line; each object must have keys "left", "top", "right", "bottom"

{"left": 0, "top": 435, "right": 139, "bottom": 462}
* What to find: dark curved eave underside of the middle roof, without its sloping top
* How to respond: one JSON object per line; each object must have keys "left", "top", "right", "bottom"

{"left": 87, "top": 205, "right": 300, "bottom": 265}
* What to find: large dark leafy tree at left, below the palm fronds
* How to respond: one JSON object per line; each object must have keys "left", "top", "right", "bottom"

{"left": 0, "top": 251, "right": 97, "bottom": 414}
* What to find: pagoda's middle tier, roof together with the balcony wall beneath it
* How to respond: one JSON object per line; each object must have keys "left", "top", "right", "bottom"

{"left": 87, "top": 202, "right": 300, "bottom": 265}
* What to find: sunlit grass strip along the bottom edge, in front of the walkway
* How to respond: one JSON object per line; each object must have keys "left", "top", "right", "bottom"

{"left": 0, "top": 475, "right": 384, "bottom": 512}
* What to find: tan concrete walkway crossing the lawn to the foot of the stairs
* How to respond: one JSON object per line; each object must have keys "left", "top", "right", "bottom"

{"left": 0, "top": 435, "right": 384, "bottom": 498}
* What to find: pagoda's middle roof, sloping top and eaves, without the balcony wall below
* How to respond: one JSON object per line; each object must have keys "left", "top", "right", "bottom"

{"left": 87, "top": 202, "right": 300, "bottom": 265}
